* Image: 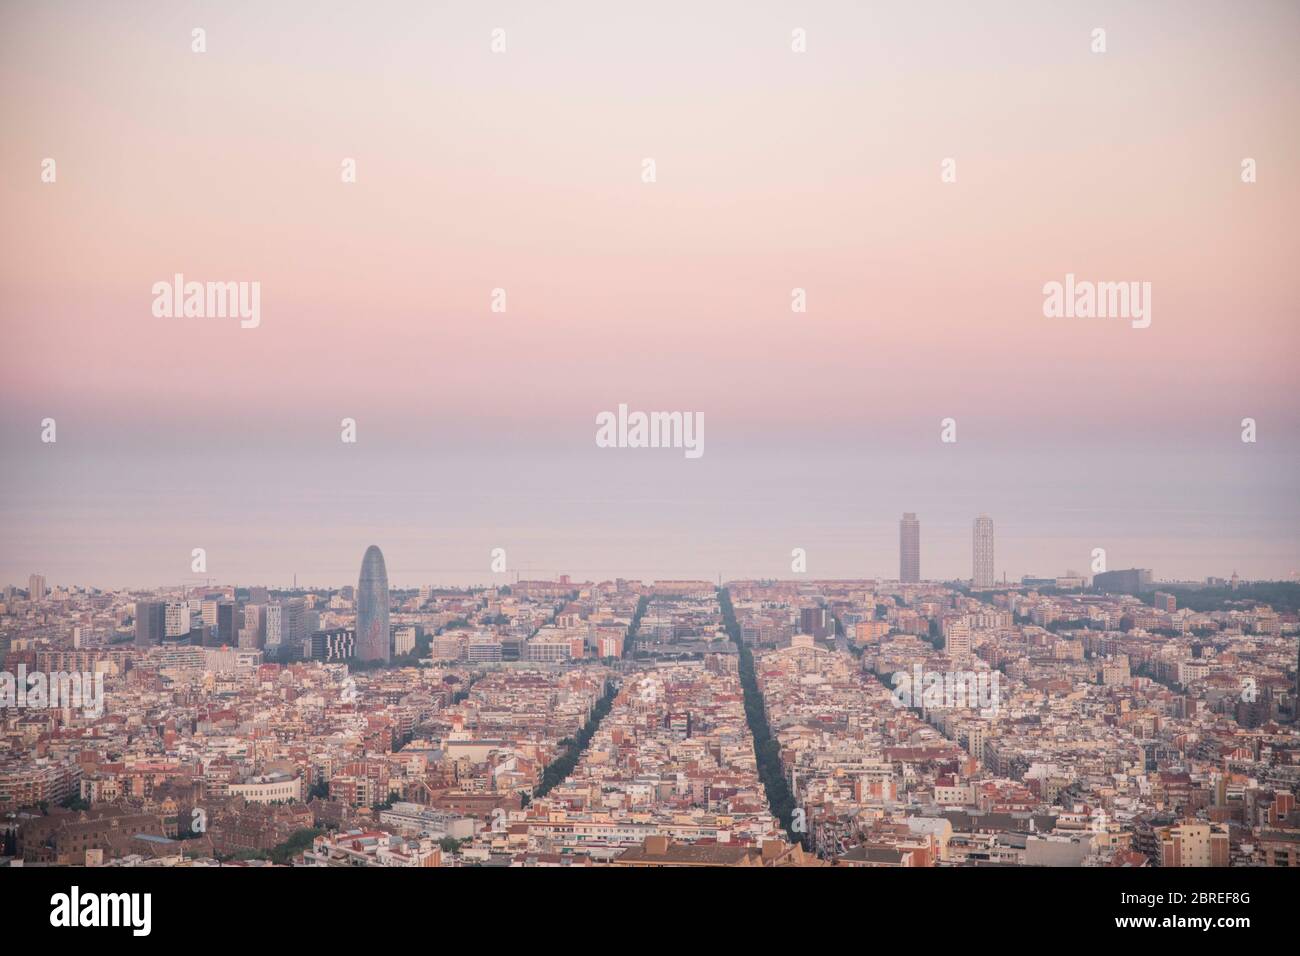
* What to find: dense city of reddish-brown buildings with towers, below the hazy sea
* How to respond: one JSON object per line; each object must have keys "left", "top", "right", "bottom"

{"left": 0, "top": 512, "right": 1300, "bottom": 868}
